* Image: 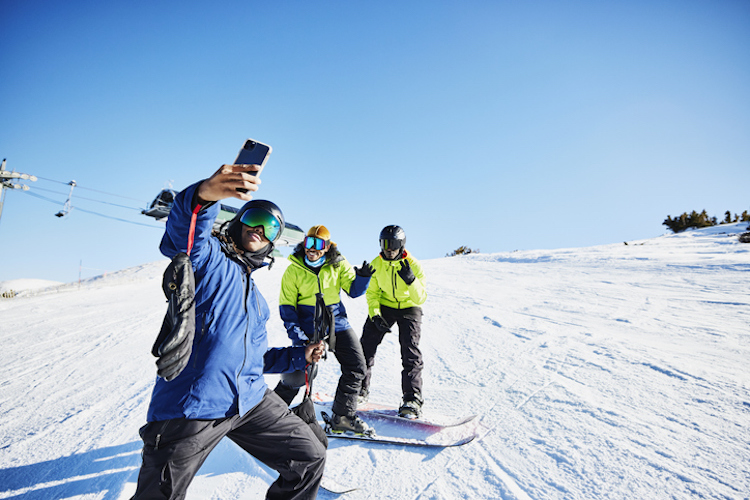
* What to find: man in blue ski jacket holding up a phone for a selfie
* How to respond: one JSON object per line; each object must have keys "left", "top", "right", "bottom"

{"left": 134, "top": 165, "right": 325, "bottom": 500}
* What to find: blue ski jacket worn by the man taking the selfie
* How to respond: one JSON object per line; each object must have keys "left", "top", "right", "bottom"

{"left": 147, "top": 183, "right": 306, "bottom": 422}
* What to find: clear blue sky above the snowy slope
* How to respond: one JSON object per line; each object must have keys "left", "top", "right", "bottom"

{"left": 0, "top": 0, "right": 750, "bottom": 282}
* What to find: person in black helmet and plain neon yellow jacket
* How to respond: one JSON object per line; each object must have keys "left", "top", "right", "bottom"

{"left": 360, "top": 226, "right": 427, "bottom": 419}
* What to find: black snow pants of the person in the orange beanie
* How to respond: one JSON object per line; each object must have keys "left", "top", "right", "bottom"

{"left": 274, "top": 328, "right": 365, "bottom": 416}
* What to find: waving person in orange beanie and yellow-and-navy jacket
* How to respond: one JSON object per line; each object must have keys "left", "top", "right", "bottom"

{"left": 275, "top": 225, "right": 373, "bottom": 434}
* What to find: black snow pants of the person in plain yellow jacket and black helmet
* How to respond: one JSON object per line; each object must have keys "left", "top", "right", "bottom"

{"left": 361, "top": 305, "right": 423, "bottom": 401}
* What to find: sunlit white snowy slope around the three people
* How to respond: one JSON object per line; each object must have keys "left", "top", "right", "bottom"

{"left": 0, "top": 224, "right": 750, "bottom": 500}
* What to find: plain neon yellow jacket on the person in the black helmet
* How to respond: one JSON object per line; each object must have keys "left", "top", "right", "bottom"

{"left": 366, "top": 251, "right": 427, "bottom": 318}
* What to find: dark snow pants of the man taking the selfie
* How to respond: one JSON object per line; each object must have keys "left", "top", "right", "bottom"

{"left": 133, "top": 390, "right": 326, "bottom": 500}
